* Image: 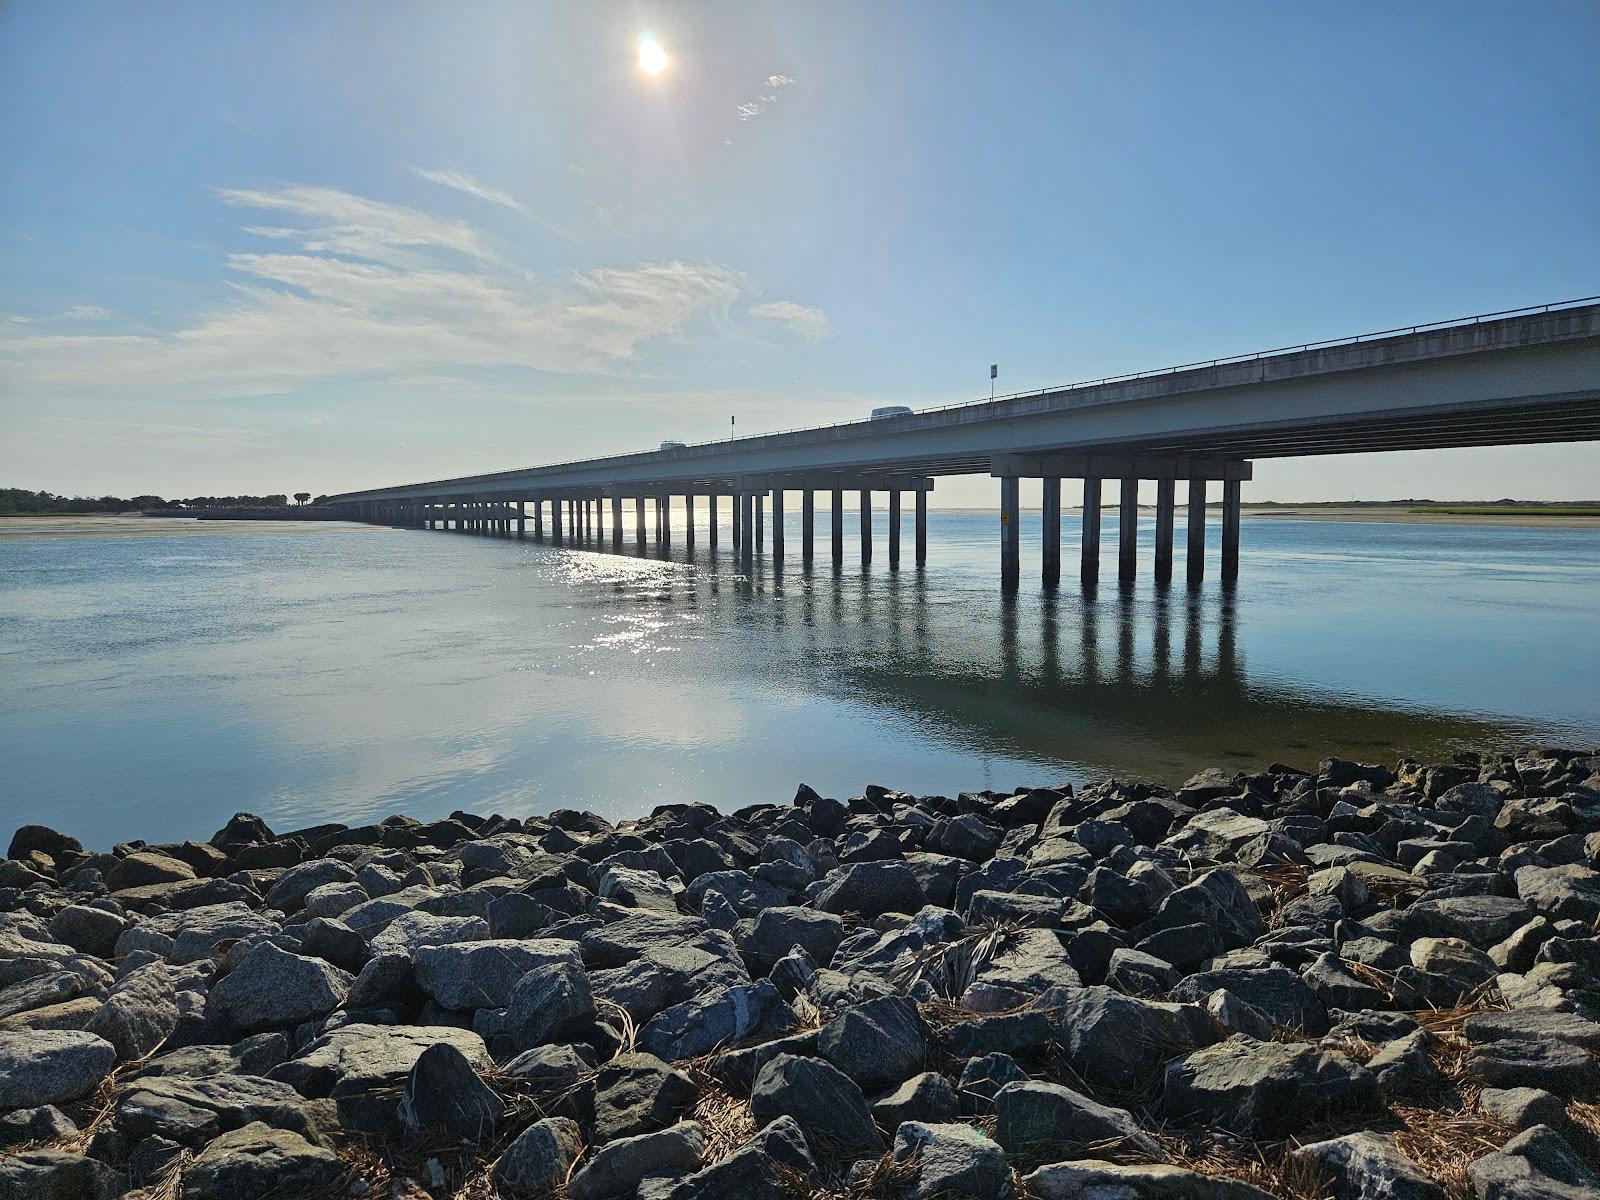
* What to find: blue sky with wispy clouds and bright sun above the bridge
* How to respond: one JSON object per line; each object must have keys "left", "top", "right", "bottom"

{"left": 0, "top": 0, "right": 1600, "bottom": 506}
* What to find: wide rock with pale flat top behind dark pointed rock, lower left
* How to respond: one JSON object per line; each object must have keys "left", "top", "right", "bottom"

{"left": 269, "top": 1024, "right": 493, "bottom": 1133}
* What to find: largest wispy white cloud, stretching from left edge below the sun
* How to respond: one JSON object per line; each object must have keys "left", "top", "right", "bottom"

{"left": 0, "top": 184, "right": 746, "bottom": 397}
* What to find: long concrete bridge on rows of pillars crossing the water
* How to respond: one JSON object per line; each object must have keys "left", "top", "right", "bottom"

{"left": 328, "top": 296, "right": 1600, "bottom": 590}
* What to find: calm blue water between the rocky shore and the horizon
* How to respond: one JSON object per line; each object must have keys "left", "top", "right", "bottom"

{"left": 0, "top": 506, "right": 1600, "bottom": 846}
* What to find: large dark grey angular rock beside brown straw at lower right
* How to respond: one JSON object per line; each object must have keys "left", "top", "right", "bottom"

{"left": 1162, "top": 1034, "right": 1378, "bottom": 1138}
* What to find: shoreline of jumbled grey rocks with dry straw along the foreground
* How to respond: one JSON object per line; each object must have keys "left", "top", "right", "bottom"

{"left": 0, "top": 749, "right": 1600, "bottom": 1200}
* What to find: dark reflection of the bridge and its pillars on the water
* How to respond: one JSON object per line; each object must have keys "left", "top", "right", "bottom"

{"left": 582, "top": 544, "right": 1504, "bottom": 784}
